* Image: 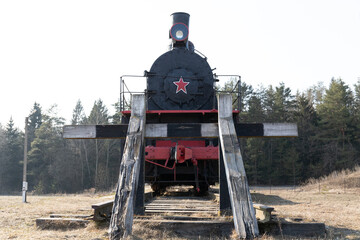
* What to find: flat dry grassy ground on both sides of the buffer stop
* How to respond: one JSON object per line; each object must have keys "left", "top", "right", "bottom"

{"left": 0, "top": 188, "right": 360, "bottom": 240}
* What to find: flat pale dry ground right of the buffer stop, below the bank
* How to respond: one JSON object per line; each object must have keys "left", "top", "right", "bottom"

{"left": 252, "top": 188, "right": 360, "bottom": 239}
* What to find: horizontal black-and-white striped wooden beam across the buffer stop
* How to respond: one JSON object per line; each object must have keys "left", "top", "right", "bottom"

{"left": 63, "top": 123, "right": 298, "bottom": 139}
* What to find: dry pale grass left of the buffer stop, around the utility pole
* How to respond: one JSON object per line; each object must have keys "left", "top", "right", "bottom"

{"left": 0, "top": 194, "right": 109, "bottom": 239}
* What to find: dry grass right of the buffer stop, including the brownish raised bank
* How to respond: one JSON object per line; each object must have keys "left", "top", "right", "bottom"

{"left": 252, "top": 167, "right": 360, "bottom": 239}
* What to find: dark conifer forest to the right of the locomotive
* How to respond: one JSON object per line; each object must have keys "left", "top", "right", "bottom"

{"left": 231, "top": 78, "right": 360, "bottom": 185}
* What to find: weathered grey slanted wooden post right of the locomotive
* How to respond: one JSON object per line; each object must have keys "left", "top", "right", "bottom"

{"left": 218, "top": 94, "right": 259, "bottom": 238}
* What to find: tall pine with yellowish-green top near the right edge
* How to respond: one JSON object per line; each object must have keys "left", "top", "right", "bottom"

{"left": 317, "top": 78, "right": 356, "bottom": 173}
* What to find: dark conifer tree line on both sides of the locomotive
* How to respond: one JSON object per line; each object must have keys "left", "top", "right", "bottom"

{"left": 0, "top": 78, "right": 360, "bottom": 194}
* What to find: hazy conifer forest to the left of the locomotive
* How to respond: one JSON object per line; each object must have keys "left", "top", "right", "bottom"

{"left": 0, "top": 99, "right": 121, "bottom": 194}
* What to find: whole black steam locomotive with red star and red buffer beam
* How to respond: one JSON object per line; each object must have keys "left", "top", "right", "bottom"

{"left": 123, "top": 12, "right": 233, "bottom": 194}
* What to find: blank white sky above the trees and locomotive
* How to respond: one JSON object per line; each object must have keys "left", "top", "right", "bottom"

{"left": 0, "top": 0, "right": 360, "bottom": 129}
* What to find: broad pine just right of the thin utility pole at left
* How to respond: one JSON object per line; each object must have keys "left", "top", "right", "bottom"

{"left": 28, "top": 106, "right": 81, "bottom": 193}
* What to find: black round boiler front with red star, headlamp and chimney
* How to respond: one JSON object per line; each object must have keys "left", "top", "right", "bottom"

{"left": 147, "top": 12, "right": 215, "bottom": 110}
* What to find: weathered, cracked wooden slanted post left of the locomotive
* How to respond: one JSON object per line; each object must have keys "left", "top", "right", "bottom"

{"left": 109, "top": 94, "right": 146, "bottom": 240}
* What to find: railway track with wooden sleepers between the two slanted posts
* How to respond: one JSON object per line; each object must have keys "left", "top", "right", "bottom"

{"left": 134, "top": 196, "right": 234, "bottom": 239}
